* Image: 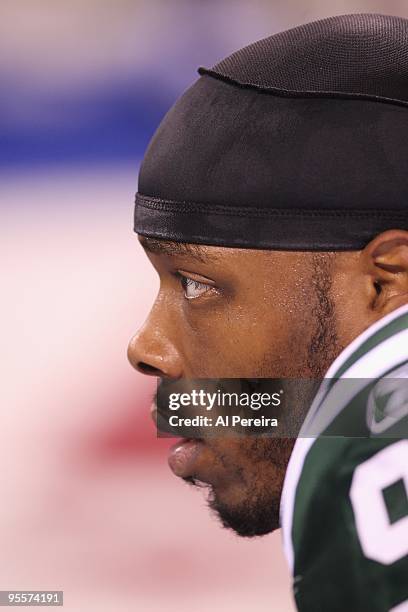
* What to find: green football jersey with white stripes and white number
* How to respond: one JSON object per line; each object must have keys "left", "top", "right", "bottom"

{"left": 281, "top": 307, "right": 408, "bottom": 612}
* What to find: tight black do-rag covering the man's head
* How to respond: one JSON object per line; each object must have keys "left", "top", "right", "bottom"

{"left": 134, "top": 14, "right": 408, "bottom": 250}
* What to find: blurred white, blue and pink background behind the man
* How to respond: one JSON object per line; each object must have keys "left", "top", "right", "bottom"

{"left": 0, "top": 0, "right": 408, "bottom": 612}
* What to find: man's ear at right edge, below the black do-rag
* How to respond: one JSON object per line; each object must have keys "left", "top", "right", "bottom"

{"left": 361, "top": 230, "right": 408, "bottom": 316}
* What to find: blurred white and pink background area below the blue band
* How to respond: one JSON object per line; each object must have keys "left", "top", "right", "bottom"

{"left": 0, "top": 168, "right": 292, "bottom": 612}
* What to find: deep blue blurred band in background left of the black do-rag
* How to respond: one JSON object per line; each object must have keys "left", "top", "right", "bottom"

{"left": 0, "top": 80, "right": 174, "bottom": 168}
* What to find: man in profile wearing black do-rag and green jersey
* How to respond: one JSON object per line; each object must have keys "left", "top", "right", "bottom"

{"left": 129, "top": 15, "right": 408, "bottom": 612}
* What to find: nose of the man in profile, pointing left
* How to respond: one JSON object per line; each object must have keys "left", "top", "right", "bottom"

{"left": 128, "top": 307, "right": 182, "bottom": 379}
